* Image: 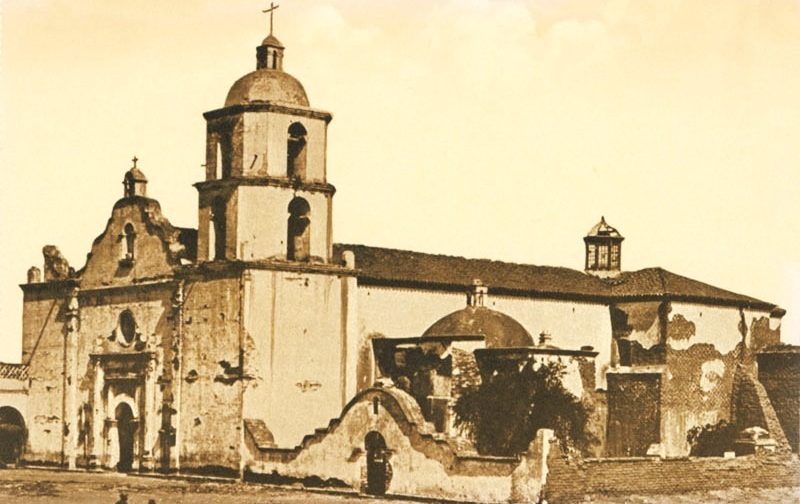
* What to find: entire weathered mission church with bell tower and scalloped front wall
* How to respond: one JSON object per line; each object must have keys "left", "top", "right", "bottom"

{"left": 7, "top": 11, "right": 798, "bottom": 504}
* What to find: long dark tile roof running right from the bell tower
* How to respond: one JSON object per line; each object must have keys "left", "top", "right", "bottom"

{"left": 334, "top": 243, "right": 775, "bottom": 309}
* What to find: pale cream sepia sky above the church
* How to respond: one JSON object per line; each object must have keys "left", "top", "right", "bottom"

{"left": 0, "top": 0, "right": 800, "bottom": 362}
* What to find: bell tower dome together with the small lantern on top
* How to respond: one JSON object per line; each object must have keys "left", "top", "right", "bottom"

{"left": 225, "top": 28, "right": 309, "bottom": 107}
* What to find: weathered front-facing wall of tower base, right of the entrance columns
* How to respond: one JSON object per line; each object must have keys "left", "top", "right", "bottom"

{"left": 177, "top": 275, "right": 242, "bottom": 474}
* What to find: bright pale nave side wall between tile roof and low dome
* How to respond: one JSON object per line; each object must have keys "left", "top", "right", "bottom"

{"left": 356, "top": 286, "right": 611, "bottom": 388}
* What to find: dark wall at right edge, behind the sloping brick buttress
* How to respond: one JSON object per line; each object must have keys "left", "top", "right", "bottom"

{"left": 758, "top": 347, "right": 800, "bottom": 453}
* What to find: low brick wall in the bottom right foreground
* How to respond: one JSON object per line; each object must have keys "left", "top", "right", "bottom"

{"left": 545, "top": 447, "right": 800, "bottom": 504}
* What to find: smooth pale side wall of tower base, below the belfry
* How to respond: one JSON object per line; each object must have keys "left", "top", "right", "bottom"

{"left": 244, "top": 270, "right": 358, "bottom": 447}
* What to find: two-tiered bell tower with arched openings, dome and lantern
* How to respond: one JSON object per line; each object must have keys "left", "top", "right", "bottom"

{"left": 195, "top": 28, "right": 335, "bottom": 264}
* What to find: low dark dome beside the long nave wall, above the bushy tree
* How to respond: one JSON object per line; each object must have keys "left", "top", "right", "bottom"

{"left": 423, "top": 306, "right": 533, "bottom": 348}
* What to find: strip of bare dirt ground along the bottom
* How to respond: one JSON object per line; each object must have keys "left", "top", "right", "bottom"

{"left": 0, "top": 469, "right": 800, "bottom": 504}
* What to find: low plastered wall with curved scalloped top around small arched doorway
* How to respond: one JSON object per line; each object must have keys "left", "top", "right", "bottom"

{"left": 247, "top": 389, "right": 520, "bottom": 502}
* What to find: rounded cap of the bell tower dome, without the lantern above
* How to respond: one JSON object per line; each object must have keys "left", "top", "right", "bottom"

{"left": 225, "top": 69, "right": 308, "bottom": 107}
